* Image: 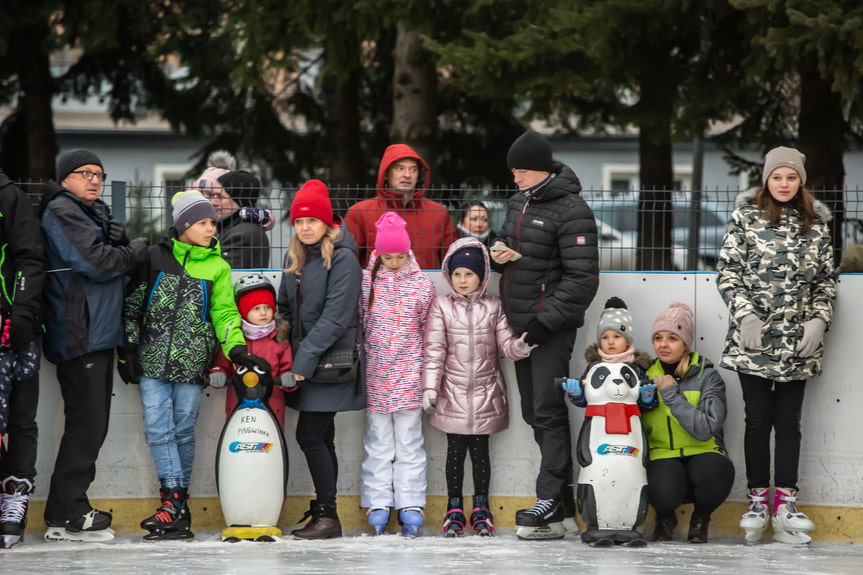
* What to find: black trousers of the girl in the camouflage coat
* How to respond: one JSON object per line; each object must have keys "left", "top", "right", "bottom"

{"left": 739, "top": 373, "right": 806, "bottom": 489}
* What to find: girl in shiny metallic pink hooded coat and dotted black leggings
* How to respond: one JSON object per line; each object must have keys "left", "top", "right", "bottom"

{"left": 423, "top": 237, "right": 531, "bottom": 537}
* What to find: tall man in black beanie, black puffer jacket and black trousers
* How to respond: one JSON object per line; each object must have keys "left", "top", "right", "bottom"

{"left": 491, "top": 130, "right": 599, "bottom": 539}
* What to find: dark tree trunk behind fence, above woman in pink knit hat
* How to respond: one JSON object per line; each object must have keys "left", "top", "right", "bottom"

{"left": 636, "top": 66, "right": 675, "bottom": 270}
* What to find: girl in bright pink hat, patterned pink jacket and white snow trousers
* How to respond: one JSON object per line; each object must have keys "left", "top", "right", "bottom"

{"left": 360, "top": 212, "right": 435, "bottom": 536}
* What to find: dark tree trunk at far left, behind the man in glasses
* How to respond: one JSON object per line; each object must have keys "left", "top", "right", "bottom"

{"left": 6, "top": 23, "right": 57, "bottom": 180}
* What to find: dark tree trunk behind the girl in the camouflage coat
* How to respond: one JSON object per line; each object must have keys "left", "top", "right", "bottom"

{"left": 799, "top": 56, "right": 848, "bottom": 265}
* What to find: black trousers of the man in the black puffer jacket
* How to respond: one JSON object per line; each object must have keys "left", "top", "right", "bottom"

{"left": 515, "top": 330, "right": 577, "bottom": 499}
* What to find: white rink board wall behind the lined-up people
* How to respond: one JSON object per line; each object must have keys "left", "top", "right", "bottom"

{"left": 28, "top": 272, "right": 863, "bottom": 507}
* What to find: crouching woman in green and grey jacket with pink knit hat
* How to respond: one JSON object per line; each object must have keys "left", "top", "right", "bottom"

{"left": 641, "top": 303, "right": 734, "bottom": 543}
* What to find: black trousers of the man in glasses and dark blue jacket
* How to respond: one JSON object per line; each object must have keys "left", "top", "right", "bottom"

{"left": 45, "top": 349, "right": 114, "bottom": 523}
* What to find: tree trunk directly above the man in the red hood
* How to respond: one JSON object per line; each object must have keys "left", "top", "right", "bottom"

{"left": 390, "top": 22, "right": 438, "bottom": 180}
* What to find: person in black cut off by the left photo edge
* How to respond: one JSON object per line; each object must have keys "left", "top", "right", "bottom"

{"left": 0, "top": 172, "right": 45, "bottom": 548}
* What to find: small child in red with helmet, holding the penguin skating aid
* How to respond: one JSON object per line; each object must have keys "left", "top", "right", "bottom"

{"left": 210, "top": 273, "right": 297, "bottom": 429}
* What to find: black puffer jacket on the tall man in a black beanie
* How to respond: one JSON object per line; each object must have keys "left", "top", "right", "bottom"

{"left": 492, "top": 163, "right": 599, "bottom": 333}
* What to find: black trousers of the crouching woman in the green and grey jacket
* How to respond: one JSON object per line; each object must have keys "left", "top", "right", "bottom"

{"left": 647, "top": 453, "right": 734, "bottom": 519}
